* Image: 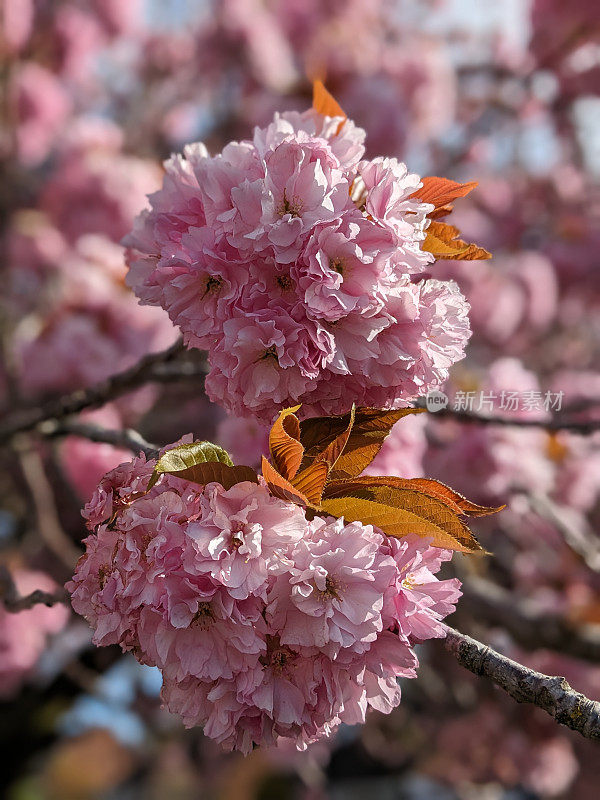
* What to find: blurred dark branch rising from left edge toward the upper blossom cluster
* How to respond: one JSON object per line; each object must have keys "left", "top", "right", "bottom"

{"left": 0, "top": 340, "right": 185, "bottom": 444}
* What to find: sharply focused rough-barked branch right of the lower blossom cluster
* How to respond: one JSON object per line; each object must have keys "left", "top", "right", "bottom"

{"left": 444, "top": 628, "right": 600, "bottom": 741}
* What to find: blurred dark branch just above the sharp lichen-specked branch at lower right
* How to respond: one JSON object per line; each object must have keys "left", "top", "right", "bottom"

{"left": 461, "top": 578, "right": 600, "bottom": 663}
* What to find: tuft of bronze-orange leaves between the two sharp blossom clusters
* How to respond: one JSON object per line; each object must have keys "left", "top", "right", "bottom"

{"left": 262, "top": 406, "right": 500, "bottom": 553}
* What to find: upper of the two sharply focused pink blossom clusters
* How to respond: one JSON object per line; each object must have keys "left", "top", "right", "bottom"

{"left": 125, "top": 110, "right": 470, "bottom": 421}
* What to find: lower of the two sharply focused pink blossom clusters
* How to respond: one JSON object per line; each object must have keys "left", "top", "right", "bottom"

{"left": 67, "top": 446, "right": 460, "bottom": 752}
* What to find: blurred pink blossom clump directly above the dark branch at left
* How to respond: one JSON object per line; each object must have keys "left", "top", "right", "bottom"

{"left": 13, "top": 234, "right": 176, "bottom": 405}
